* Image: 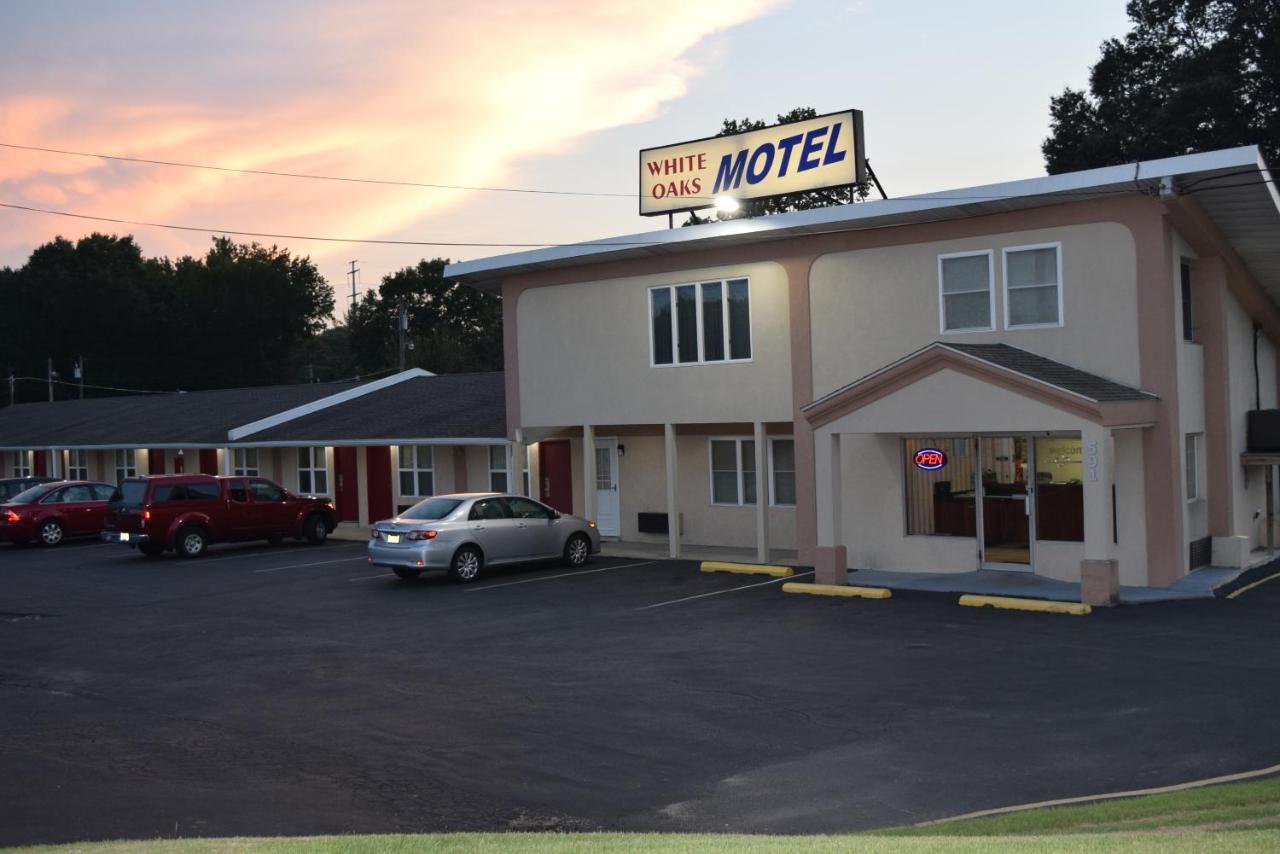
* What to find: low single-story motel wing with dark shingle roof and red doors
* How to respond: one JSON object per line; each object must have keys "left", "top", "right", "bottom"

{"left": 0, "top": 370, "right": 514, "bottom": 538}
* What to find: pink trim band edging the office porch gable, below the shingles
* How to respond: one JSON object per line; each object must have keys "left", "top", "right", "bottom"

{"left": 800, "top": 342, "right": 1158, "bottom": 429}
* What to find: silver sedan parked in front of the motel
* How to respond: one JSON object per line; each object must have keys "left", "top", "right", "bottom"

{"left": 369, "top": 493, "right": 600, "bottom": 581}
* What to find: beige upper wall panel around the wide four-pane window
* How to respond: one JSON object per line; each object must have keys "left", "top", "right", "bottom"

{"left": 517, "top": 264, "right": 792, "bottom": 428}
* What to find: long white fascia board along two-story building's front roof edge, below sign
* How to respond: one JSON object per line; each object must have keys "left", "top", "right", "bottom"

{"left": 444, "top": 146, "right": 1262, "bottom": 280}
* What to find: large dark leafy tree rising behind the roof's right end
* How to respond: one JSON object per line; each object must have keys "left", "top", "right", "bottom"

{"left": 1042, "top": 0, "right": 1280, "bottom": 173}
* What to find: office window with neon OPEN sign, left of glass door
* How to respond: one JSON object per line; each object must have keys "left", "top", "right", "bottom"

{"left": 902, "top": 437, "right": 978, "bottom": 536}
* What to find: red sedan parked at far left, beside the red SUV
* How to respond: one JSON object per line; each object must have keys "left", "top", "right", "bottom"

{"left": 0, "top": 480, "right": 115, "bottom": 545}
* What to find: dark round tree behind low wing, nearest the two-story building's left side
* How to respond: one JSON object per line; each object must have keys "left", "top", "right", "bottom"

{"left": 347, "top": 259, "right": 502, "bottom": 374}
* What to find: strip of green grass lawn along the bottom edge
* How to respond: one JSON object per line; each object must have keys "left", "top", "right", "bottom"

{"left": 18, "top": 780, "right": 1280, "bottom": 854}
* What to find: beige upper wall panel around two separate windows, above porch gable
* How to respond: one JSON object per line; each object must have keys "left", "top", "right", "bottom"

{"left": 810, "top": 223, "right": 1139, "bottom": 397}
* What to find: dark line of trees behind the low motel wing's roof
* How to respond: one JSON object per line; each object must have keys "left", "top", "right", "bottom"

{"left": 0, "top": 234, "right": 502, "bottom": 406}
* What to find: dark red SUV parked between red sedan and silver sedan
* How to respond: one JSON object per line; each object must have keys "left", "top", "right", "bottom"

{"left": 102, "top": 475, "right": 338, "bottom": 557}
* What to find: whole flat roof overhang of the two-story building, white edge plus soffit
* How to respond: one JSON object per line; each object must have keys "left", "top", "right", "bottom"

{"left": 444, "top": 146, "right": 1280, "bottom": 302}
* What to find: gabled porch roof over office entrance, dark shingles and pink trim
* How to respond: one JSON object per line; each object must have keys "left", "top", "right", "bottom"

{"left": 800, "top": 341, "right": 1160, "bottom": 426}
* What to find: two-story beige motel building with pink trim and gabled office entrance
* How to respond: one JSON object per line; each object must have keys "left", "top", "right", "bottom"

{"left": 445, "top": 147, "right": 1280, "bottom": 594}
